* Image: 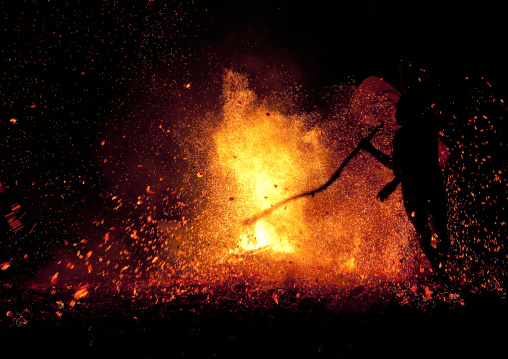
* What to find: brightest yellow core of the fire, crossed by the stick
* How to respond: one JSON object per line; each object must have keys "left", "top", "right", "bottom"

{"left": 214, "top": 71, "right": 324, "bottom": 253}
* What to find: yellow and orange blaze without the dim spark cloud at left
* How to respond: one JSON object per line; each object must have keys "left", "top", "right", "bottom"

{"left": 132, "top": 71, "right": 413, "bottom": 283}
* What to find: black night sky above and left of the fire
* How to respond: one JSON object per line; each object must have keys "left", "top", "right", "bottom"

{"left": 0, "top": 0, "right": 508, "bottom": 278}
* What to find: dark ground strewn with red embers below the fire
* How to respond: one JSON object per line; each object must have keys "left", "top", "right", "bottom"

{"left": 0, "top": 282, "right": 508, "bottom": 358}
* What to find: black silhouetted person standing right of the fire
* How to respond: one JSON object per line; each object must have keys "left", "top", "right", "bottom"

{"left": 362, "top": 90, "right": 450, "bottom": 279}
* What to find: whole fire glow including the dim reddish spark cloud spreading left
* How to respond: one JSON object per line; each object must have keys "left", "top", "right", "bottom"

{"left": 48, "top": 71, "right": 423, "bottom": 292}
